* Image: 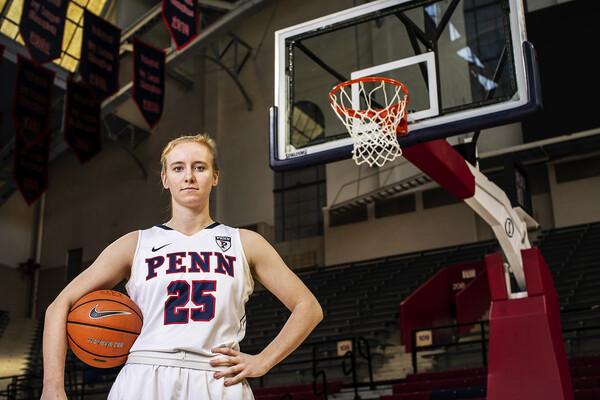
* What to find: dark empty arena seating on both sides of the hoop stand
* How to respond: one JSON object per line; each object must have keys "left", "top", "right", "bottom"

{"left": 242, "top": 222, "right": 600, "bottom": 385}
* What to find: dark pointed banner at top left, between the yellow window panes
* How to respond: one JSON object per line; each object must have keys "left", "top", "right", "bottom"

{"left": 19, "top": 0, "right": 69, "bottom": 64}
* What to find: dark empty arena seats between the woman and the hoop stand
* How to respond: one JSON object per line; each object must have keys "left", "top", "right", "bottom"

{"left": 242, "top": 240, "right": 497, "bottom": 385}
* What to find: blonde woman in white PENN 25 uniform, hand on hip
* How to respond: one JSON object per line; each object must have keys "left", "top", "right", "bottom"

{"left": 42, "top": 135, "right": 323, "bottom": 400}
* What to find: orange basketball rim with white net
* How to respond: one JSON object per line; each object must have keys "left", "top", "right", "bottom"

{"left": 329, "top": 77, "right": 408, "bottom": 167}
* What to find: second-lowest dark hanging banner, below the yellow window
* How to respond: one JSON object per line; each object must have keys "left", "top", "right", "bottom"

{"left": 64, "top": 79, "right": 102, "bottom": 164}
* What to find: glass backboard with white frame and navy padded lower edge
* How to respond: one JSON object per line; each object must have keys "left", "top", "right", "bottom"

{"left": 270, "top": 0, "right": 541, "bottom": 171}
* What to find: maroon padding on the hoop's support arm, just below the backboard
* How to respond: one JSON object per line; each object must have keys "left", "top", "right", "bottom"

{"left": 402, "top": 139, "right": 475, "bottom": 200}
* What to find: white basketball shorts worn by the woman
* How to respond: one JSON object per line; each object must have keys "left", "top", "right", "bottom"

{"left": 108, "top": 364, "right": 254, "bottom": 400}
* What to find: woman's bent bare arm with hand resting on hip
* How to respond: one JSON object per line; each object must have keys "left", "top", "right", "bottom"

{"left": 211, "top": 229, "right": 323, "bottom": 386}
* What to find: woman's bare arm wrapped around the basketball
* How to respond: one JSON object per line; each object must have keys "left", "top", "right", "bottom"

{"left": 42, "top": 231, "right": 138, "bottom": 400}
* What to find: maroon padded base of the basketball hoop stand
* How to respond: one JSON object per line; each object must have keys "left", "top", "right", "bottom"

{"left": 486, "top": 248, "right": 573, "bottom": 400}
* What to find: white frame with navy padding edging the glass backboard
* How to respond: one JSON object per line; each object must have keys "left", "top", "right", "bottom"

{"left": 269, "top": 0, "right": 541, "bottom": 171}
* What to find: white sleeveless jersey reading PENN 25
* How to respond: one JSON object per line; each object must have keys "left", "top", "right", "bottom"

{"left": 126, "top": 223, "right": 254, "bottom": 358}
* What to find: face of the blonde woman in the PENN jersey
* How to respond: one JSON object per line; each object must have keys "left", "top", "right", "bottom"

{"left": 161, "top": 142, "right": 219, "bottom": 206}
